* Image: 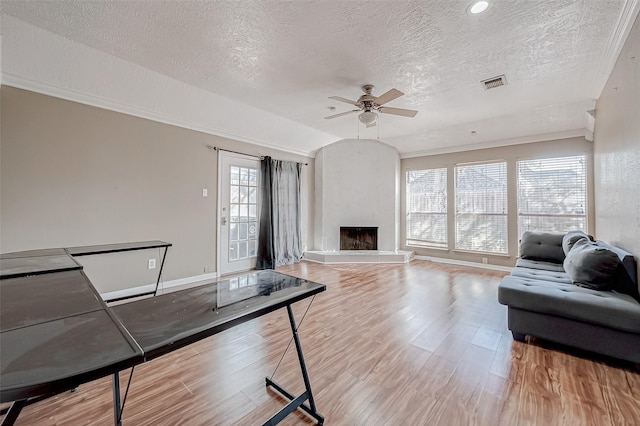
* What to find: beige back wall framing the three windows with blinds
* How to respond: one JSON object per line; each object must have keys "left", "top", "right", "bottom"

{"left": 400, "top": 138, "right": 595, "bottom": 266}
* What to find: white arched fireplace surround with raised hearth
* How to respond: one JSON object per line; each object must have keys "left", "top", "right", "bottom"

{"left": 312, "top": 139, "right": 410, "bottom": 262}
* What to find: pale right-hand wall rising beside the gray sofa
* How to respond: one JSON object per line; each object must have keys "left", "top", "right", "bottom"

{"left": 594, "top": 18, "right": 640, "bottom": 259}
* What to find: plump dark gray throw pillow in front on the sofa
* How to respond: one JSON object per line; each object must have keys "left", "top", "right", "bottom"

{"left": 563, "top": 237, "right": 620, "bottom": 290}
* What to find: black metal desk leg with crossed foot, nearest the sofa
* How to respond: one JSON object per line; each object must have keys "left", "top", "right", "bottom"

{"left": 264, "top": 305, "right": 324, "bottom": 425}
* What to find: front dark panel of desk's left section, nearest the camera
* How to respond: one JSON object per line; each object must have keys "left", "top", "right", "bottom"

{"left": 0, "top": 309, "right": 143, "bottom": 402}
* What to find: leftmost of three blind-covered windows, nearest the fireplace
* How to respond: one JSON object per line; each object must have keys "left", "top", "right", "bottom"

{"left": 406, "top": 168, "right": 447, "bottom": 248}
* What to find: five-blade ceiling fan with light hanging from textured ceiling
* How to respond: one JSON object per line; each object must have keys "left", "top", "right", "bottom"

{"left": 325, "top": 84, "right": 418, "bottom": 127}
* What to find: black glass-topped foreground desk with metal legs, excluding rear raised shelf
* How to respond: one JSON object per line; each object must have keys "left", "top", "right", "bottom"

{"left": 0, "top": 248, "right": 326, "bottom": 425}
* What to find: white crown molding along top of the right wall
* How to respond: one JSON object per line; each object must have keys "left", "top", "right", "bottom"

{"left": 591, "top": 0, "right": 640, "bottom": 99}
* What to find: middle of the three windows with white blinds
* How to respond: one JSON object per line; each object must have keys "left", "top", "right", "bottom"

{"left": 455, "top": 162, "right": 507, "bottom": 254}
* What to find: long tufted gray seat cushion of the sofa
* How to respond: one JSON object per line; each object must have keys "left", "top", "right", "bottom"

{"left": 498, "top": 275, "right": 640, "bottom": 334}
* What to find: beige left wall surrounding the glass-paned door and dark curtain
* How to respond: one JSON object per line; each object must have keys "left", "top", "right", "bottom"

{"left": 0, "top": 86, "right": 314, "bottom": 291}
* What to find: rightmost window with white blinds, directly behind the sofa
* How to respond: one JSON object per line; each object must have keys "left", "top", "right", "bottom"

{"left": 518, "top": 155, "right": 587, "bottom": 240}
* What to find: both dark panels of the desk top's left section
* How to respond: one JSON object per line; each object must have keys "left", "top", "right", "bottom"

{"left": 0, "top": 271, "right": 143, "bottom": 402}
